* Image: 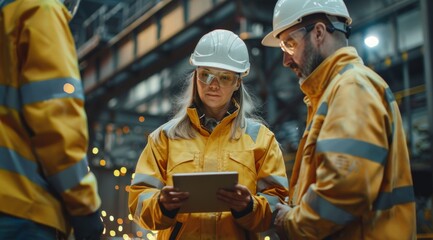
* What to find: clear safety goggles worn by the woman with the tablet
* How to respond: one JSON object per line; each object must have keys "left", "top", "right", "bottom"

{"left": 196, "top": 68, "right": 240, "bottom": 87}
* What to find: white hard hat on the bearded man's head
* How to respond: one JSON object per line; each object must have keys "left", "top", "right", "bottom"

{"left": 262, "top": 0, "right": 352, "bottom": 47}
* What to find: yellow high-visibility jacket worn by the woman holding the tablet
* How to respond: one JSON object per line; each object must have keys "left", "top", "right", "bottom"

{"left": 129, "top": 105, "right": 288, "bottom": 240}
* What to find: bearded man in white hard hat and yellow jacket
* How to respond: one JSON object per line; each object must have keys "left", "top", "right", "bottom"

{"left": 262, "top": 0, "right": 416, "bottom": 239}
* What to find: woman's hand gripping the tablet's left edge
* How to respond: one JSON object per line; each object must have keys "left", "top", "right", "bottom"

{"left": 158, "top": 186, "right": 189, "bottom": 211}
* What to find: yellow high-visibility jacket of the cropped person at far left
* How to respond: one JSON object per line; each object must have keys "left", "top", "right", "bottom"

{"left": 0, "top": 0, "right": 100, "bottom": 233}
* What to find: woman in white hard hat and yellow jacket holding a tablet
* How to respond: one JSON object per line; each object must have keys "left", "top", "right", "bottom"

{"left": 129, "top": 29, "right": 288, "bottom": 239}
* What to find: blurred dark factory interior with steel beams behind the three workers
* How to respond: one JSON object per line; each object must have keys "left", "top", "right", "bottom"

{"left": 70, "top": 0, "right": 433, "bottom": 239}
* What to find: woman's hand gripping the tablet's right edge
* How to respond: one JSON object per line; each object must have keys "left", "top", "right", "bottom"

{"left": 217, "top": 184, "right": 251, "bottom": 212}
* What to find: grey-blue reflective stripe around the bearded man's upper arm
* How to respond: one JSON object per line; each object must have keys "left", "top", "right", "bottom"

{"left": 316, "top": 139, "right": 388, "bottom": 165}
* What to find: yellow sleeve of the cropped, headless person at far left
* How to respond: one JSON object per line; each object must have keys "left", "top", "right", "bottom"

{"left": 17, "top": 0, "right": 101, "bottom": 216}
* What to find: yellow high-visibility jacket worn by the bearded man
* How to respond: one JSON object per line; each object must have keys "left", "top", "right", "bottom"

{"left": 284, "top": 47, "right": 416, "bottom": 239}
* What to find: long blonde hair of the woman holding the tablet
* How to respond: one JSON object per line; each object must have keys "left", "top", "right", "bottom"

{"left": 151, "top": 70, "right": 265, "bottom": 141}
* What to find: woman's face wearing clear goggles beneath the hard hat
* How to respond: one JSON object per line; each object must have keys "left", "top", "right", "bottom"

{"left": 196, "top": 67, "right": 241, "bottom": 119}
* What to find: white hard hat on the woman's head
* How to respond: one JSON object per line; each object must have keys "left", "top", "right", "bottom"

{"left": 190, "top": 29, "right": 250, "bottom": 76}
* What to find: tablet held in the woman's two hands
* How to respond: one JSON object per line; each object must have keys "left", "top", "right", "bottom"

{"left": 173, "top": 172, "right": 238, "bottom": 213}
